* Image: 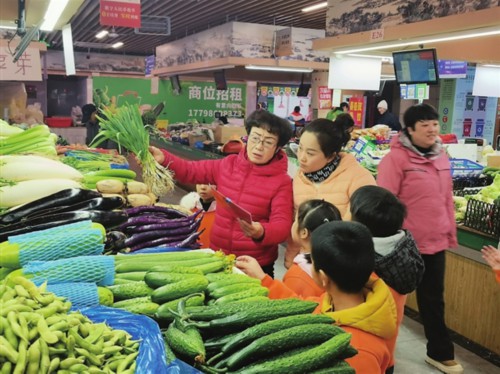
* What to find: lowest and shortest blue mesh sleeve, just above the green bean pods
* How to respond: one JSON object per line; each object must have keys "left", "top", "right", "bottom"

{"left": 47, "top": 283, "right": 99, "bottom": 310}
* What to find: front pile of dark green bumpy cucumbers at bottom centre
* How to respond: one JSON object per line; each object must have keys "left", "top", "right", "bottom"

{"left": 163, "top": 295, "right": 357, "bottom": 374}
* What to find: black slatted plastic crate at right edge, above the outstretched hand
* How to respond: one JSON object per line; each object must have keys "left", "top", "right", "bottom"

{"left": 463, "top": 199, "right": 500, "bottom": 238}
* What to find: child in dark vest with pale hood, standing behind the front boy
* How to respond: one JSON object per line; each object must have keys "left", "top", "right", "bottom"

{"left": 351, "top": 186, "right": 424, "bottom": 373}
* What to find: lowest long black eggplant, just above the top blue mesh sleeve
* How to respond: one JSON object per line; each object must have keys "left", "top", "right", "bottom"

{"left": 0, "top": 210, "right": 128, "bottom": 241}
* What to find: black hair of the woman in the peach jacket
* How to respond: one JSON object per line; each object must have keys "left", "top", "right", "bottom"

{"left": 304, "top": 113, "right": 354, "bottom": 158}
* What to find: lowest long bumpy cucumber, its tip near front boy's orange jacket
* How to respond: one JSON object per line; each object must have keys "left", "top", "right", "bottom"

{"left": 233, "top": 333, "right": 351, "bottom": 374}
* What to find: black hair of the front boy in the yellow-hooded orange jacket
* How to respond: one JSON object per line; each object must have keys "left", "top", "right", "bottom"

{"left": 311, "top": 221, "right": 375, "bottom": 294}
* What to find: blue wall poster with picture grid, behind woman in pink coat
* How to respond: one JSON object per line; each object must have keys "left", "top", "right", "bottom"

{"left": 439, "top": 66, "right": 498, "bottom": 144}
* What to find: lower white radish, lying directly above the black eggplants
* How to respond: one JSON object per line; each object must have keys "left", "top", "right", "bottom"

{"left": 0, "top": 178, "right": 82, "bottom": 208}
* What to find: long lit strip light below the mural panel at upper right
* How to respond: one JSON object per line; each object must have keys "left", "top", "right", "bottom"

{"left": 335, "top": 26, "right": 500, "bottom": 54}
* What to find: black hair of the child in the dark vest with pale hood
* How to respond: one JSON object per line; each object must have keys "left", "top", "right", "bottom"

{"left": 350, "top": 186, "right": 406, "bottom": 238}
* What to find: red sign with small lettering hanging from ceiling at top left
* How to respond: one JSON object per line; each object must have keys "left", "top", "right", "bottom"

{"left": 100, "top": 0, "right": 141, "bottom": 28}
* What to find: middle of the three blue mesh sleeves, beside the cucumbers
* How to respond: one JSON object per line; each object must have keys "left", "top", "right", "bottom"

{"left": 23, "top": 255, "right": 115, "bottom": 286}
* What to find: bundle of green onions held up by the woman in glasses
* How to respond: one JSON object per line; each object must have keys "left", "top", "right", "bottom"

{"left": 91, "top": 104, "right": 174, "bottom": 196}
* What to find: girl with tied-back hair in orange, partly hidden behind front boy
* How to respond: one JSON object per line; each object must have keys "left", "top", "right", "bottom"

{"left": 283, "top": 199, "right": 341, "bottom": 297}
